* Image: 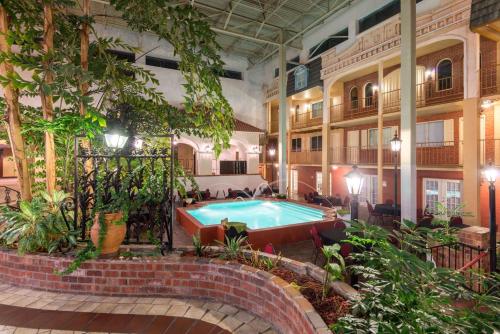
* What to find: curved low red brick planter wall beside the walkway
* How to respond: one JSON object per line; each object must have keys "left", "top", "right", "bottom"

{"left": 0, "top": 250, "right": 353, "bottom": 334}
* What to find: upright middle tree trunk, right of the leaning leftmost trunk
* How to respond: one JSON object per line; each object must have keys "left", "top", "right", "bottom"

{"left": 40, "top": 2, "right": 56, "bottom": 194}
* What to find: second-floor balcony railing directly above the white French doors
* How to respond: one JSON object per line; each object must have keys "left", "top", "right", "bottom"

{"left": 331, "top": 141, "right": 461, "bottom": 166}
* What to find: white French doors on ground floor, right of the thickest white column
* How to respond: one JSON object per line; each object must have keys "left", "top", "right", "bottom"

{"left": 423, "top": 178, "right": 463, "bottom": 212}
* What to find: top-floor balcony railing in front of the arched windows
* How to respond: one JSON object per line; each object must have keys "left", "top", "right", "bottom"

{"left": 330, "top": 75, "right": 464, "bottom": 122}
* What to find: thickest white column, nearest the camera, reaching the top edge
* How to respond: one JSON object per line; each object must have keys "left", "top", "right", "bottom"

{"left": 400, "top": 0, "right": 417, "bottom": 221}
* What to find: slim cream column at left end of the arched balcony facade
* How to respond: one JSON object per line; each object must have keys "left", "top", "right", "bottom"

{"left": 321, "top": 84, "right": 332, "bottom": 196}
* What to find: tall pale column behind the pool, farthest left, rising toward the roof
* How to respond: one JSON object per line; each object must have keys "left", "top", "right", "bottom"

{"left": 278, "top": 36, "right": 288, "bottom": 194}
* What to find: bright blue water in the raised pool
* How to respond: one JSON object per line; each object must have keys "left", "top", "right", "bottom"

{"left": 187, "top": 200, "right": 323, "bottom": 230}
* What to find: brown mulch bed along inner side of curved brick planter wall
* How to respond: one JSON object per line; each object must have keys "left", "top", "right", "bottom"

{"left": 182, "top": 251, "right": 350, "bottom": 325}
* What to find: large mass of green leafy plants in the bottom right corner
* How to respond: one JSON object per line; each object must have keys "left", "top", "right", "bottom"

{"left": 331, "top": 222, "right": 500, "bottom": 334}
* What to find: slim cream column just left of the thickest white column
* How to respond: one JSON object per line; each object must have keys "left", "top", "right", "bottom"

{"left": 377, "top": 62, "right": 384, "bottom": 203}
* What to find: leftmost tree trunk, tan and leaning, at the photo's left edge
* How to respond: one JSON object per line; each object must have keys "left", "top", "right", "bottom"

{"left": 0, "top": 5, "right": 31, "bottom": 201}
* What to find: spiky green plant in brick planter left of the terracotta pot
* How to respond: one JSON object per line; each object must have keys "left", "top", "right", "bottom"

{"left": 0, "top": 191, "right": 77, "bottom": 254}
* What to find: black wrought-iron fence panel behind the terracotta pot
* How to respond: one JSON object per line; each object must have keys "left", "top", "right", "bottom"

{"left": 73, "top": 135, "right": 175, "bottom": 250}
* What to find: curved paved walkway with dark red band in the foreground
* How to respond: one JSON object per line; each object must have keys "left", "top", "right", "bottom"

{"left": 0, "top": 284, "right": 276, "bottom": 334}
